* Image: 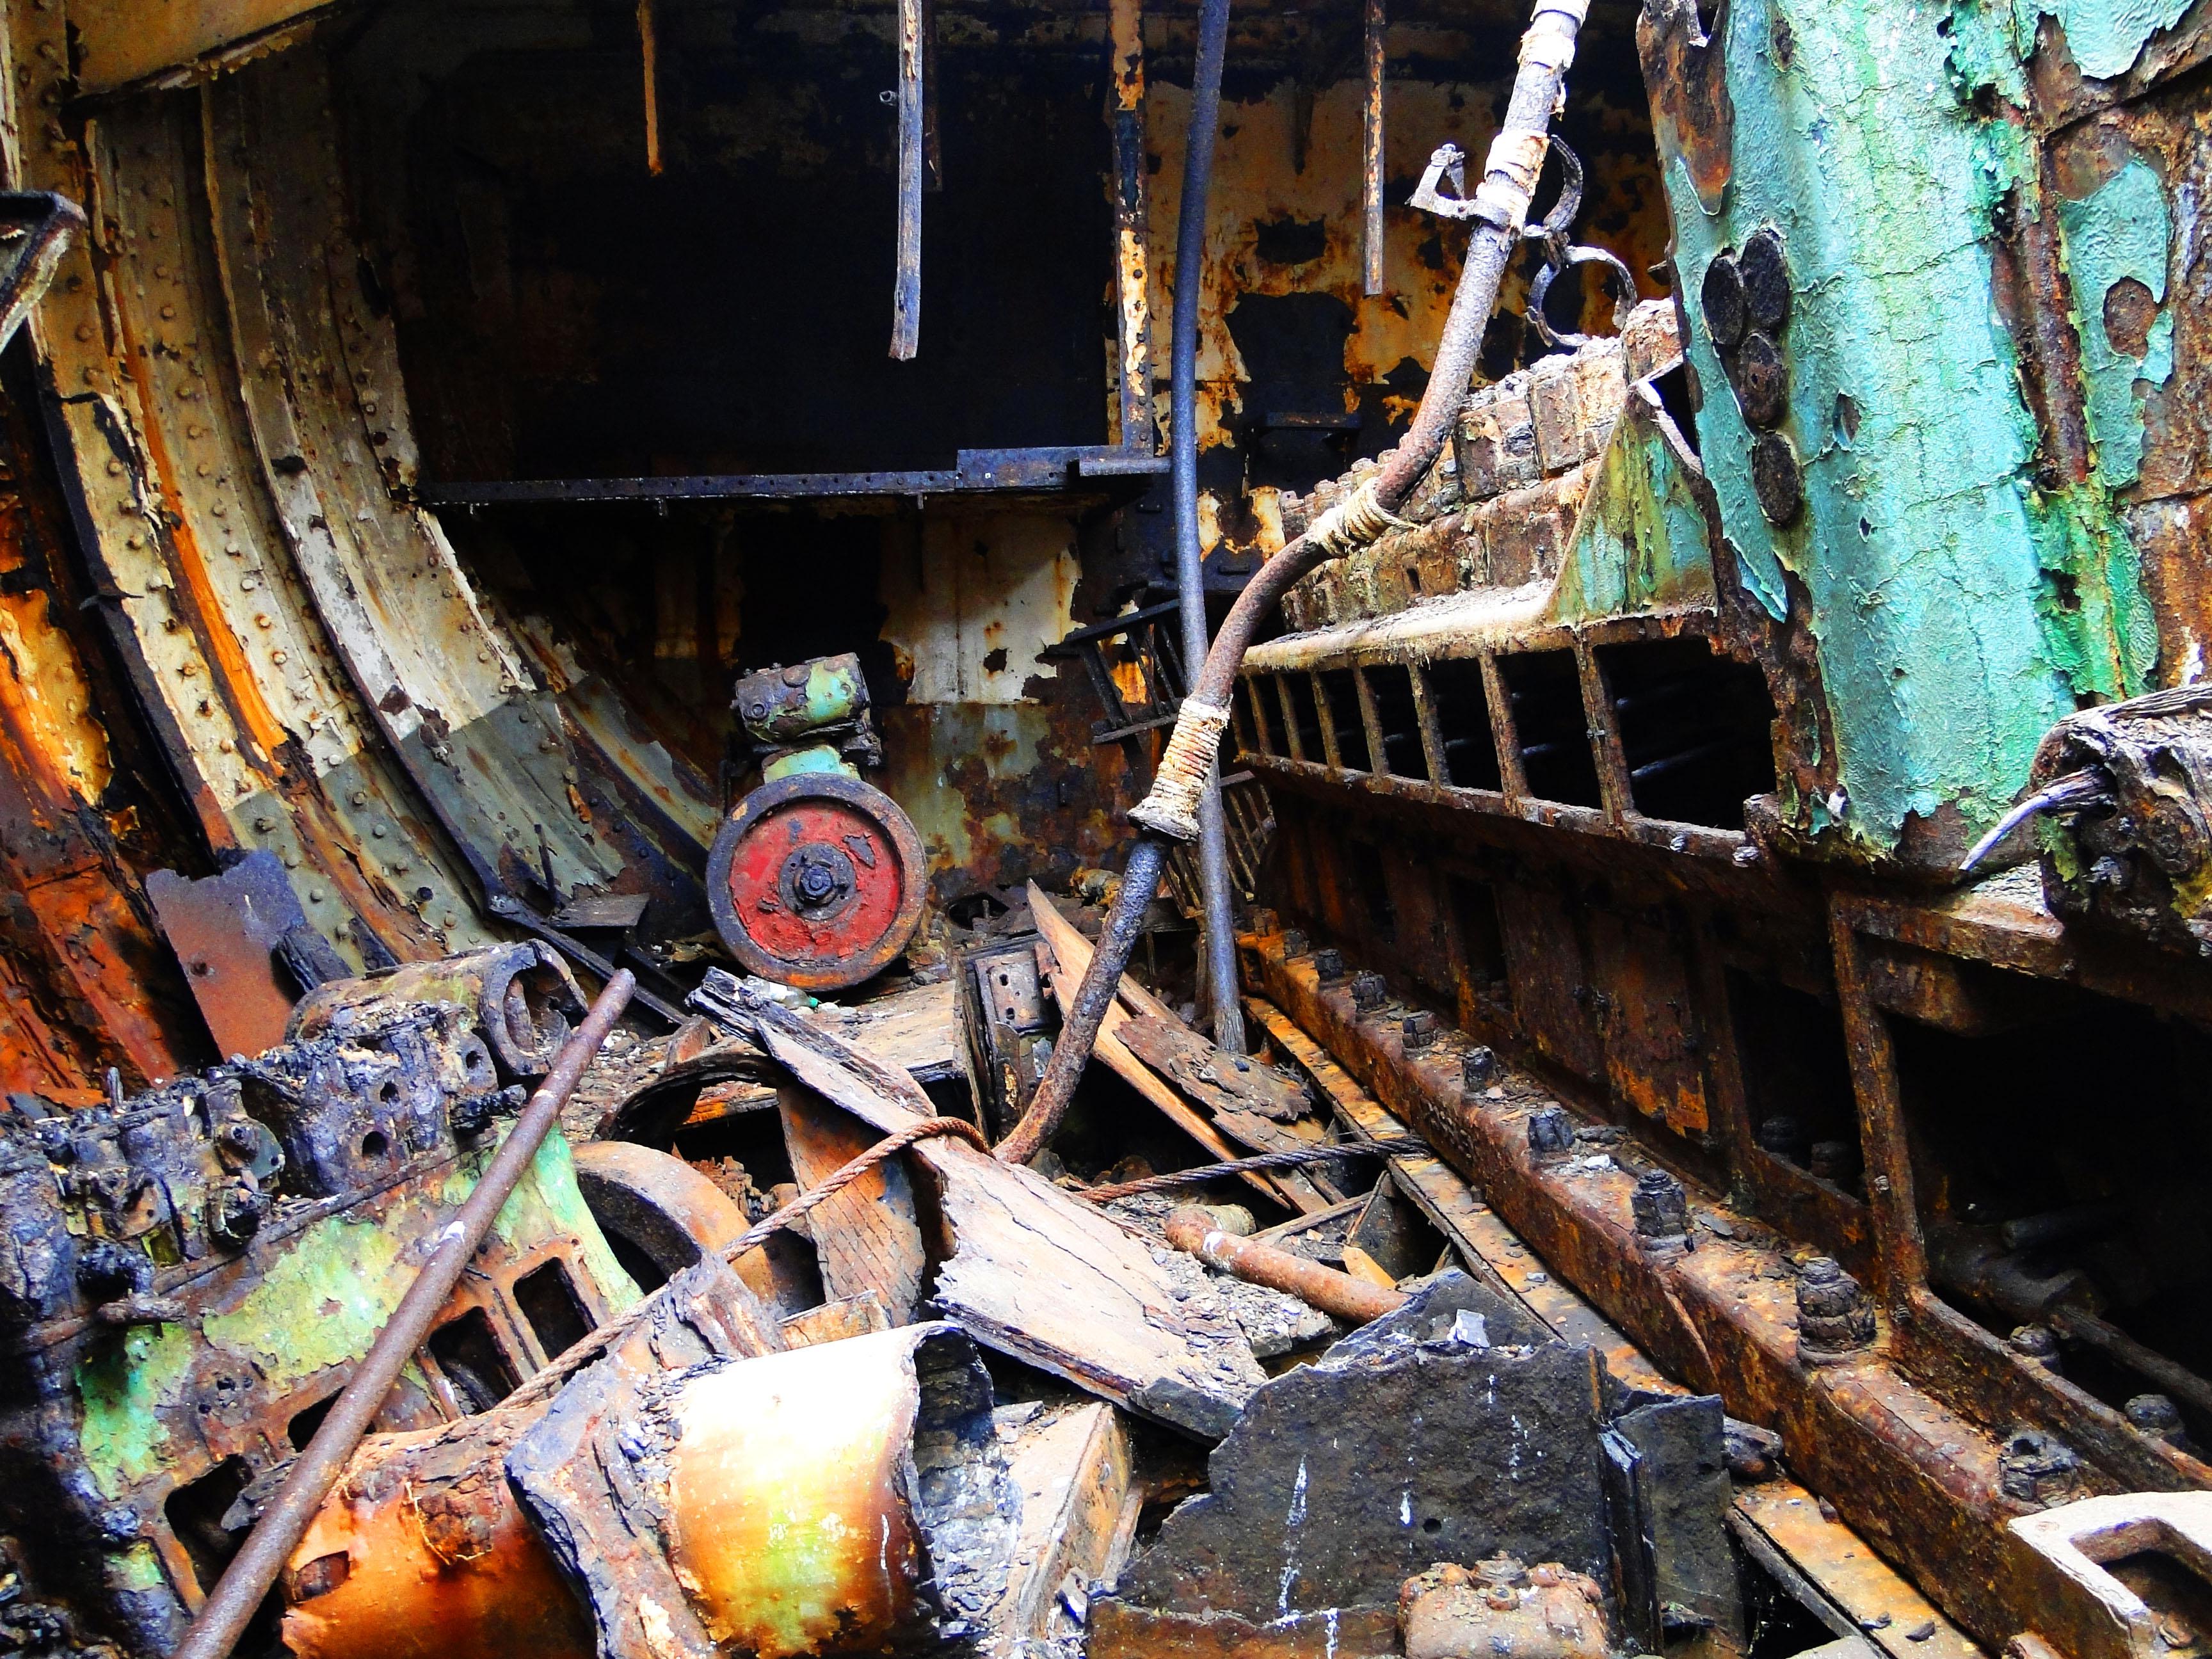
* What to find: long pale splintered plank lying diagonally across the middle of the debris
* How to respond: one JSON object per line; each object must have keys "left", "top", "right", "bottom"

{"left": 748, "top": 1000, "right": 1265, "bottom": 1440}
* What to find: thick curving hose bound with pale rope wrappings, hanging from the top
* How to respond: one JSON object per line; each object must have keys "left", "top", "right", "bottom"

{"left": 998, "top": 0, "right": 1582, "bottom": 1164}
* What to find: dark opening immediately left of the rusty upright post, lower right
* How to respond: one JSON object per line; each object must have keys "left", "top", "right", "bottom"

{"left": 1727, "top": 969, "right": 1860, "bottom": 1197}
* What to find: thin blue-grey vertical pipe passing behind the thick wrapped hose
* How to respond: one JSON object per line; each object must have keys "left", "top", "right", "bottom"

{"left": 1168, "top": 0, "right": 1246, "bottom": 1055}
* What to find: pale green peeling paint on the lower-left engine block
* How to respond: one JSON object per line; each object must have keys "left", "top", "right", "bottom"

{"left": 77, "top": 1135, "right": 639, "bottom": 1498}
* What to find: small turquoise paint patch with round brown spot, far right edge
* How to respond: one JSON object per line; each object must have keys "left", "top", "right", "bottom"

{"left": 2060, "top": 157, "right": 2174, "bottom": 489}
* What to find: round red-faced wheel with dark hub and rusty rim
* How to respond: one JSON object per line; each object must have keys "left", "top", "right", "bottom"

{"left": 705, "top": 772, "right": 929, "bottom": 991}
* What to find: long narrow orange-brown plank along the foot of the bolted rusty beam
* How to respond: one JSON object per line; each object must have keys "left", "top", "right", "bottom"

{"left": 1246, "top": 995, "right": 1681, "bottom": 1393}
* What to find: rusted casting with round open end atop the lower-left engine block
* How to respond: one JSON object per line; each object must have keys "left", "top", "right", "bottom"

{"left": 285, "top": 940, "right": 584, "bottom": 1077}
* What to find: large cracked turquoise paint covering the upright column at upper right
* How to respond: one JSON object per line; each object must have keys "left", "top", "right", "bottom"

{"left": 1665, "top": 0, "right": 2165, "bottom": 854}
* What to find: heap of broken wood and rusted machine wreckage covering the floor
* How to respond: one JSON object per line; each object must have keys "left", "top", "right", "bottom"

{"left": 0, "top": 887, "right": 2070, "bottom": 1659}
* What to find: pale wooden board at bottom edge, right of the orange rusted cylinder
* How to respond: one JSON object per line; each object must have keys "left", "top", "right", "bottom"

{"left": 984, "top": 1400, "right": 1132, "bottom": 1659}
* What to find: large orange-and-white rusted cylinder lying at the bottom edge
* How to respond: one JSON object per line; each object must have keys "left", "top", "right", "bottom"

{"left": 283, "top": 1323, "right": 1018, "bottom": 1659}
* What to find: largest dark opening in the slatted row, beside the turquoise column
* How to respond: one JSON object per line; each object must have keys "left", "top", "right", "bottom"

{"left": 1597, "top": 639, "right": 1774, "bottom": 830}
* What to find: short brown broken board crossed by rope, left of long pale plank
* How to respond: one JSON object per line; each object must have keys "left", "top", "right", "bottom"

{"left": 776, "top": 1086, "right": 929, "bottom": 1325}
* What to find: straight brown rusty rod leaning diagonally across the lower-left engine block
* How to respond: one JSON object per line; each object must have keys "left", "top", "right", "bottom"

{"left": 173, "top": 969, "right": 637, "bottom": 1659}
